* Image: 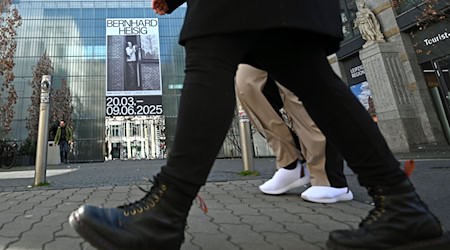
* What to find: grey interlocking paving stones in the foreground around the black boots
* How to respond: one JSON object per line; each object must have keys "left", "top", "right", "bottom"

{"left": 0, "top": 180, "right": 370, "bottom": 250}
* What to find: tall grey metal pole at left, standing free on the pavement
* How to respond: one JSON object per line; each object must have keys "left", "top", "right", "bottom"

{"left": 34, "top": 75, "right": 52, "bottom": 186}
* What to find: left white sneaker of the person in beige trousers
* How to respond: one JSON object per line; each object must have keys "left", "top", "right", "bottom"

{"left": 259, "top": 161, "right": 310, "bottom": 194}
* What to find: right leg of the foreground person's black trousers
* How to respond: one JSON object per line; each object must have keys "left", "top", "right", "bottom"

{"left": 255, "top": 31, "right": 406, "bottom": 186}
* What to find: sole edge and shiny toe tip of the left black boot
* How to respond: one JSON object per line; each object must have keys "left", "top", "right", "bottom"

{"left": 69, "top": 211, "right": 120, "bottom": 250}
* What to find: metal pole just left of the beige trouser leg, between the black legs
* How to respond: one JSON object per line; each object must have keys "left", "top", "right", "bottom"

{"left": 237, "top": 99, "right": 253, "bottom": 171}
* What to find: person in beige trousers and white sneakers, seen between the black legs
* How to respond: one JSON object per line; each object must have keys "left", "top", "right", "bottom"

{"left": 236, "top": 64, "right": 353, "bottom": 203}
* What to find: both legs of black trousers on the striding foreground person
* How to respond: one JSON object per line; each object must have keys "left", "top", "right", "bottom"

{"left": 161, "top": 30, "right": 406, "bottom": 190}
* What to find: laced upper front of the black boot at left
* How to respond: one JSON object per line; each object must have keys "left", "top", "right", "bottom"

{"left": 117, "top": 177, "right": 167, "bottom": 216}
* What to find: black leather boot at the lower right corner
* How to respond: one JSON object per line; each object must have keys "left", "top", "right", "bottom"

{"left": 327, "top": 180, "right": 450, "bottom": 250}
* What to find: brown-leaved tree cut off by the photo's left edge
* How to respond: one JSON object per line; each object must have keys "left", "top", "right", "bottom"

{"left": 0, "top": 0, "right": 22, "bottom": 138}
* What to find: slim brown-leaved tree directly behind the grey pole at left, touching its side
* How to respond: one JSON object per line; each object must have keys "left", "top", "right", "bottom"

{"left": 26, "top": 52, "right": 53, "bottom": 142}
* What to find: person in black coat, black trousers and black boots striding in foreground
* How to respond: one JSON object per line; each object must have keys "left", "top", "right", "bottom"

{"left": 69, "top": 0, "right": 450, "bottom": 250}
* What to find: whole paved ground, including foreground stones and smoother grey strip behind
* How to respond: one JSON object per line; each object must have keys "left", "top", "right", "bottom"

{"left": 0, "top": 158, "right": 450, "bottom": 250}
